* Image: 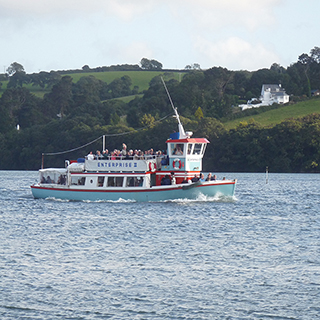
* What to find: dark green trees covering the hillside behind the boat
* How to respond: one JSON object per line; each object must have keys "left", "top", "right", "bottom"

{"left": 0, "top": 47, "right": 320, "bottom": 172}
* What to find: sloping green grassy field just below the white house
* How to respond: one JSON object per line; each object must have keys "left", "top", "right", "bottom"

{"left": 224, "top": 98, "right": 320, "bottom": 130}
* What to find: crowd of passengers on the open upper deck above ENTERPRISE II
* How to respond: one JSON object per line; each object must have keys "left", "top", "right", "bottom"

{"left": 87, "top": 143, "right": 167, "bottom": 161}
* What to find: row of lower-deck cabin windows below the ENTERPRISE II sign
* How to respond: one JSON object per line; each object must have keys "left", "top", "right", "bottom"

{"left": 71, "top": 176, "right": 144, "bottom": 187}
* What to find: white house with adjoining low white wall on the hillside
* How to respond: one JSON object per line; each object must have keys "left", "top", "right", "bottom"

{"left": 239, "top": 84, "right": 289, "bottom": 110}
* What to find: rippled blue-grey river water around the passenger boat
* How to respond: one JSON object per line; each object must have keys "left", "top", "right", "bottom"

{"left": 0, "top": 171, "right": 320, "bottom": 320}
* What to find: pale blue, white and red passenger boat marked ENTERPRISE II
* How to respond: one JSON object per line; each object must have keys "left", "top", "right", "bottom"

{"left": 31, "top": 79, "right": 237, "bottom": 202}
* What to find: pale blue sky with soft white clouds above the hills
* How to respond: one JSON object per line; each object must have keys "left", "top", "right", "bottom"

{"left": 0, "top": 0, "right": 320, "bottom": 73}
